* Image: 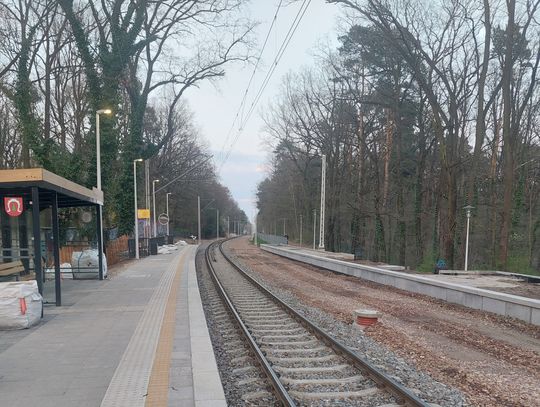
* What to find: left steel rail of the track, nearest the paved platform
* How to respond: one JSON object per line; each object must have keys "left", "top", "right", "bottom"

{"left": 205, "top": 242, "right": 296, "bottom": 407}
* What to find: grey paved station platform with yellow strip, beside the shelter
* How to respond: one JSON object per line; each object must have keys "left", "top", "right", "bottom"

{"left": 0, "top": 246, "right": 227, "bottom": 407}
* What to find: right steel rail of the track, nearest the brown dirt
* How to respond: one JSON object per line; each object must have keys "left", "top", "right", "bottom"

{"left": 219, "top": 239, "right": 430, "bottom": 407}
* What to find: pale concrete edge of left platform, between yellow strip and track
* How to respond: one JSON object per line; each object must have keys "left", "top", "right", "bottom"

{"left": 188, "top": 246, "right": 227, "bottom": 407}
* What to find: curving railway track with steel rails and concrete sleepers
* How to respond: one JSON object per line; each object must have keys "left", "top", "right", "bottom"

{"left": 205, "top": 241, "right": 429, "bottom": 407}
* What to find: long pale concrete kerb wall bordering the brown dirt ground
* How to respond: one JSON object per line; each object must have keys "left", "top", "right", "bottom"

{"left": 261, "top": 245, "right": 540, "bottom": 325}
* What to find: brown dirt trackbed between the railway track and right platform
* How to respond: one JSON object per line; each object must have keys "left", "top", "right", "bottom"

{"left": 227, "top": 239, "right": 540, "bottom": 407}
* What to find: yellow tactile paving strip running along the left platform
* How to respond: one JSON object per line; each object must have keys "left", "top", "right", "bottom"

{"left": 145, "top": 253, "right": 185, "bottom": 407}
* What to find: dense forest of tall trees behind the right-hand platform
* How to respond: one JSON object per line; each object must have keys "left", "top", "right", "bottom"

{"left": 257, "top": 0, "right": 540, "bottom": 272}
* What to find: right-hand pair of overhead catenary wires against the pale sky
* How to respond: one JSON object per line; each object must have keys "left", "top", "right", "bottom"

{"left": 219, "top": 0, "right": 311, "bottom": 170}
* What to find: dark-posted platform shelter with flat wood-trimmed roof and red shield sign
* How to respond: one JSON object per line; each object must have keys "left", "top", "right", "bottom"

{"left": 0, "top": 168, "right": 103, "bottom": 306}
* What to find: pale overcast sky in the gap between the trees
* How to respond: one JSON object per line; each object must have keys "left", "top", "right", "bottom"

{"left": 187, "top": 0, "right": 339, "bottom": 219}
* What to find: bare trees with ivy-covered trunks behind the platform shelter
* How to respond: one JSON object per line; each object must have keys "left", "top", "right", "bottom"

{"left": 0, "top": 0, "right": 249, "bottom": 241}
